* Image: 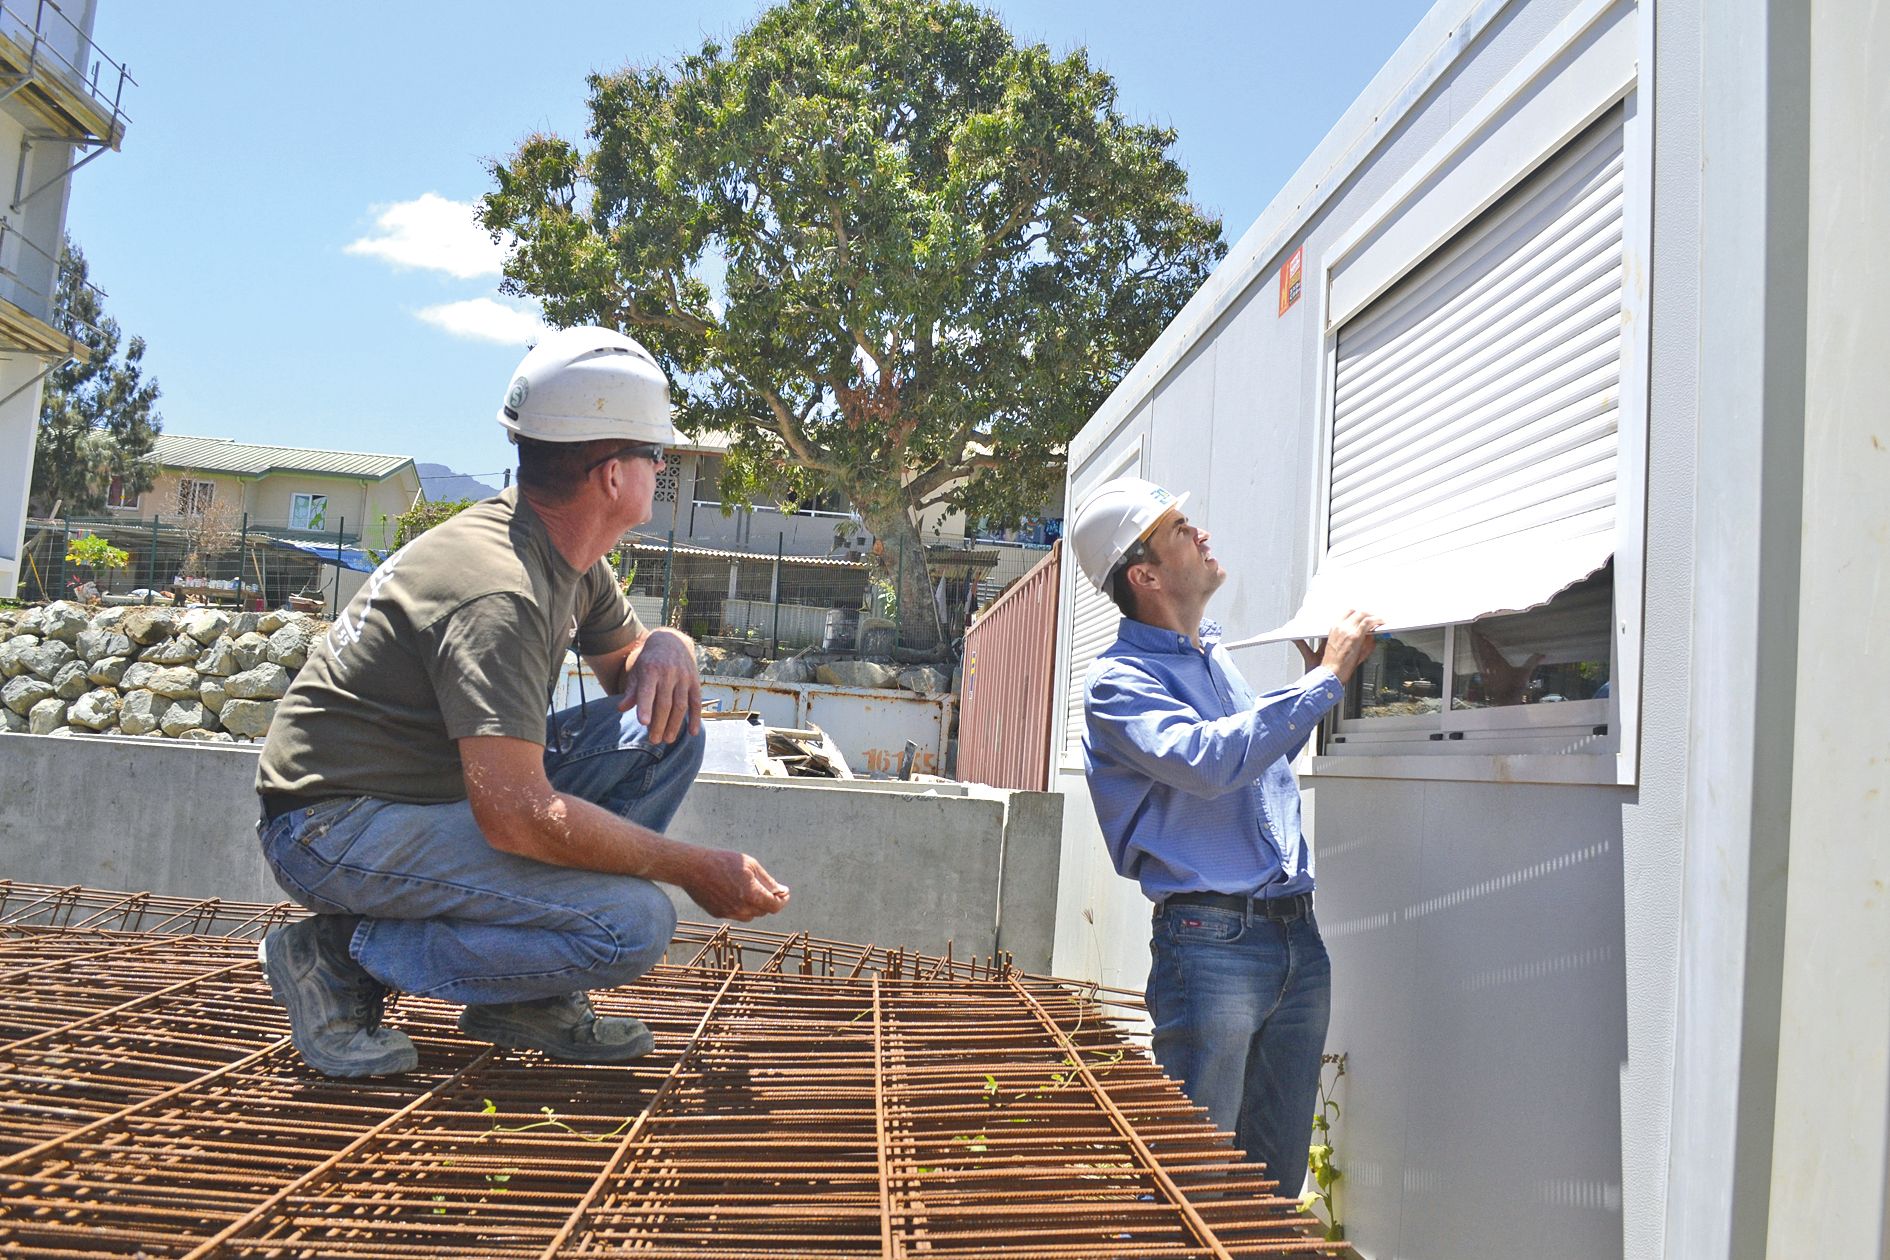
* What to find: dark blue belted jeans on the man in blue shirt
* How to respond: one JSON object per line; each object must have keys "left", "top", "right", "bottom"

{"left": 1147, "top": 905, "right": 1332, "bottom": 1196}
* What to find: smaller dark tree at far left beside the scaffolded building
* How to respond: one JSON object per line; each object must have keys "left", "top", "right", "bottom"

{"left": 30, "top": 236, "right": 164, "bottom": 514}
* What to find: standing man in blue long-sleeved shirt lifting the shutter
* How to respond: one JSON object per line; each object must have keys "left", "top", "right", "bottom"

{"left": 1072, "top": 478, "right": 1380, "bottom": 1196}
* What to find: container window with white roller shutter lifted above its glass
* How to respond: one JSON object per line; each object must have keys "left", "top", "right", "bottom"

{"left": 1259, "top": 106, "right": 1624, "bottom": 754}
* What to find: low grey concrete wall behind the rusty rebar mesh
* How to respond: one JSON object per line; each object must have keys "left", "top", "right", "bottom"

{"left": 0, "top": 735, "right": 1062, "bottom": 971}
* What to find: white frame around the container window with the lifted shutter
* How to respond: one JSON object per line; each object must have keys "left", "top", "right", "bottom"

{"left": 1304, "top": 0, "right": 1654, "bottom": 784}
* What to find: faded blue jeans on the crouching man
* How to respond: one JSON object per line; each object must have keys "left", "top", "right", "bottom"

{"left": 259, "top": 695, "right": 703, "bottom": 1005}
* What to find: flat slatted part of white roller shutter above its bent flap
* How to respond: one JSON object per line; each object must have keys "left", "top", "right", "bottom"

{"left": 1327, "top": 111, "right": 1622, "bottom": 567}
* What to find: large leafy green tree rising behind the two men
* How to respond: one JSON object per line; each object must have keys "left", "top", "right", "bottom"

{"left": 480, "top": 0, "right": 1225, "bottom": 646}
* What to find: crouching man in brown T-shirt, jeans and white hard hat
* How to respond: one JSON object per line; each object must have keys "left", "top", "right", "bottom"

{"left": 257, "top": 329, "right": 788, "bottom": 1077}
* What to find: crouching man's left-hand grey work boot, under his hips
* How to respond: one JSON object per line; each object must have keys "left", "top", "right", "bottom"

{"left": 255, "top": 914, "right": 420, "bottom": 1077}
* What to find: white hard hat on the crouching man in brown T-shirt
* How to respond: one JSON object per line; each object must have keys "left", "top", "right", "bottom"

{"left": 499, "top": 329, "right": 677, "bottom": 446}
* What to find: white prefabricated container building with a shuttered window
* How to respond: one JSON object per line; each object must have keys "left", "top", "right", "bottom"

{"left": 1055, "top": 0, "right": 1890, "bottom": 1260}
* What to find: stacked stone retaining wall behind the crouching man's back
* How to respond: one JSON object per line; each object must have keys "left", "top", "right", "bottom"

{"left": 0, "top": 601, "right": 327, "bottom": 742}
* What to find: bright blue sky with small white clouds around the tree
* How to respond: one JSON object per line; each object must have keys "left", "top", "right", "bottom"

{"left": 68, "top": 0, "right": 1429, "bottom": 482}
